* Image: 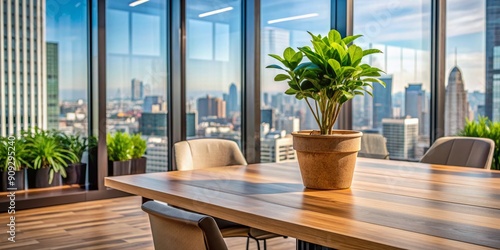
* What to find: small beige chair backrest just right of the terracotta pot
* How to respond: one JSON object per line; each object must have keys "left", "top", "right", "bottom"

{"left": 358, "top": 133, "right": 389, "bottom": 159}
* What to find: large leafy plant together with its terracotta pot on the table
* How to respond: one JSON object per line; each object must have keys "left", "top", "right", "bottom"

{"left": 267, "top": 30, "right": 385, "bottom": 189}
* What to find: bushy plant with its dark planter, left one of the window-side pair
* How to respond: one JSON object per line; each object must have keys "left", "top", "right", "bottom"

{"left": 106, "top": 132, "right": 133, "bottom": 176}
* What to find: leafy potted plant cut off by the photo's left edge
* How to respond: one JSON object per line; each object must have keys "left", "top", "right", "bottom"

{"left": 0, "top": 136, "right": 31, "bottom": 192}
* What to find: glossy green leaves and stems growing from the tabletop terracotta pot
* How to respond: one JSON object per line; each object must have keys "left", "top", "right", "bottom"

{"left": 267, "top": 30, "right": 385, "bottom": 134}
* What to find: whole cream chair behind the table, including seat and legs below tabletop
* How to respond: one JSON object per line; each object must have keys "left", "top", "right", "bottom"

{"left": 174, "top": 139, "right": 283, "bottom": 250}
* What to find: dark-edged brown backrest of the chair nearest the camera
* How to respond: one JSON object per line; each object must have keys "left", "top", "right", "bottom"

{"left": 142, "top": 201, "right": 227, "bottom": 250}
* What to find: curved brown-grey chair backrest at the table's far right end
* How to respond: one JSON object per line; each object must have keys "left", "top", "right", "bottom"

{"left": 420, "top": 137, "right": 495, "bottom": 169}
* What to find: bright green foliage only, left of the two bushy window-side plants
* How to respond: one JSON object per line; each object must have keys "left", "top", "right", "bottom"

{"left": 107, "top": 132, "right": 134, "bottom": 161}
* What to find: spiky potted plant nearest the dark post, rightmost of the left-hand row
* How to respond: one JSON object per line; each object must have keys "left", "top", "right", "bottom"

{"left": 59, "top": 133, "right": 87, "bottom": 185}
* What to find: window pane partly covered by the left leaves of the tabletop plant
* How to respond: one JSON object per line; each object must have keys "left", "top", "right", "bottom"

{"left": 260, "top": 0, "right": 330, "bottom": 162}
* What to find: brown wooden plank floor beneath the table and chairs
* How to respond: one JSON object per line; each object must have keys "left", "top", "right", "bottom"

{"left": 0, "top": 196, "right": 295, "bottom": 250}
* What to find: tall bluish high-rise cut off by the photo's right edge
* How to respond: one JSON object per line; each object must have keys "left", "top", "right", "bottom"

{"left": 485, "top": 0, "right": 500, "bottom": 121}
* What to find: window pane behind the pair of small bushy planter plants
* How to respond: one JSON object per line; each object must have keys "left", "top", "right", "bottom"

{"left": 106, "top": 0, "right": 168, "bottom": 173}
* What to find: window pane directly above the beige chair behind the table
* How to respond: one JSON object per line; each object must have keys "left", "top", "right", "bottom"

{"left": 186, "top": 0, "right": 242, "bottom": 145}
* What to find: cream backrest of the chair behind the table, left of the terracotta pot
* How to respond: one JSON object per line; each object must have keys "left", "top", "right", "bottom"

{"left": 174, "top": 139, "right": 247, "bottom": 170}
